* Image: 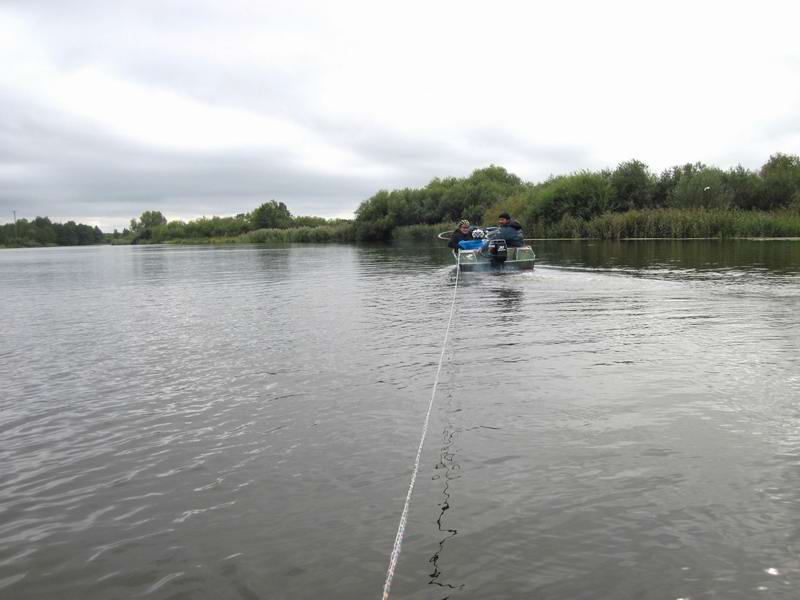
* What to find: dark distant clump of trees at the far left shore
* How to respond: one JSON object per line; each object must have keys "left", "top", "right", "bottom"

{"left": 0, "top": 217, "right": 105, "bottom": 247}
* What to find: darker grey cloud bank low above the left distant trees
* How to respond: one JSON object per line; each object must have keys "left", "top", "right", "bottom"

{"left": 0, "top": 93, "right": 376, "bottom": 223}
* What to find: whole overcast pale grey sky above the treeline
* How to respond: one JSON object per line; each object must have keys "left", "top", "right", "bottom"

{"left": 0, "top": 0, "right": 800, "bottom": 231}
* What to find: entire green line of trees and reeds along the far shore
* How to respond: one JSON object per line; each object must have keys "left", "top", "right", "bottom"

{"left": 7, "top": 153, "right": 800, "bottom": 246}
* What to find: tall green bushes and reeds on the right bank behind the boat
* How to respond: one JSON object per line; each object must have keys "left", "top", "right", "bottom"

{"left": 355, "top": 153, "right": 800, "bottom": 240}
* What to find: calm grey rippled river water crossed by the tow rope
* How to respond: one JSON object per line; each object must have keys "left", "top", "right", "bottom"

{"left": 0, "top": 241, "right": 800, "bottom": 600}
